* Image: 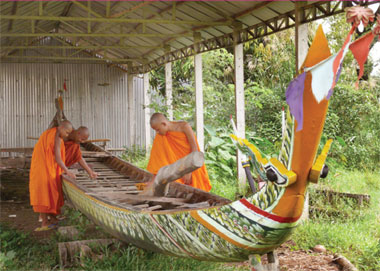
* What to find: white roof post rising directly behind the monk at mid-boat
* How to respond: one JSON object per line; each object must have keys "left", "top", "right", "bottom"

{"left": 194, "top": 33, "right": 204, "bottom": 152}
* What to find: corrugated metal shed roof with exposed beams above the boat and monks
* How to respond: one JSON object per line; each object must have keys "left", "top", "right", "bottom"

{"left": 0, "top": 1, "right": 379, "bottom": 73}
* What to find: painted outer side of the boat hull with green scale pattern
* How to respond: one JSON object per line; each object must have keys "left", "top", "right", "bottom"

{"left": 63, "top": 179, "right": 298, "bottom": 262}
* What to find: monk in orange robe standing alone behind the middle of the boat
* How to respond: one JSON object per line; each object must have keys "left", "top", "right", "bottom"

{"left": 147, "top": 113, "right": 211, "bottom": 192}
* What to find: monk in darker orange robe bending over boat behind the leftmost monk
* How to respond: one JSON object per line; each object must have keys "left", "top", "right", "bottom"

{"left": 65, "top": 126, "right": 98, "bottom": 179}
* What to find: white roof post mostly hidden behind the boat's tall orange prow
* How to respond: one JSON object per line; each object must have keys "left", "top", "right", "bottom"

{"left": 295, "top": 1, "right": 309, "bottom": 220}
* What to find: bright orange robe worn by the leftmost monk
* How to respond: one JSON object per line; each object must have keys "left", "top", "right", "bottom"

{"left": 29, "top": 127, "right": 65, "bottom": 214}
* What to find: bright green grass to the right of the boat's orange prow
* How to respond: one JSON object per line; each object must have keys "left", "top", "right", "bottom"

{"left": 292, "top": 170, "right": 380, "bottom": 270}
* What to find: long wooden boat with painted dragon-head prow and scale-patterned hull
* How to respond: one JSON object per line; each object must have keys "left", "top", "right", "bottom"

{"left": 63, "top": 9, "right": 376, "bottom": 262}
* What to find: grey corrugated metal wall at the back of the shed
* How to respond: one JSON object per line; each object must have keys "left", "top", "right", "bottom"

{"left": 0, "top": 63, "right": 145, "bottom": 148}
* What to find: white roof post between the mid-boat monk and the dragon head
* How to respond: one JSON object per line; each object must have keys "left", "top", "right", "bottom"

{"left": 233, "top": 24, "right": 246, "bottom": 194}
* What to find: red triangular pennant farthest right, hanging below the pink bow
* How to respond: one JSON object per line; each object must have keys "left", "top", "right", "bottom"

{"left": 350, "top": 32, "right": 375, "bottom": 85}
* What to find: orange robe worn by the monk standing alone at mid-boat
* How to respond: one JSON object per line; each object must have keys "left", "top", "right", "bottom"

{"left": 147, "top": 132, "right": 211, "bottom": 192}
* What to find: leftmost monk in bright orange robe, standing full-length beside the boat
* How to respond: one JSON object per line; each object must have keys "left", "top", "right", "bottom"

{"left": 29, "top": 121, "right": 76, "bottom": 231}
